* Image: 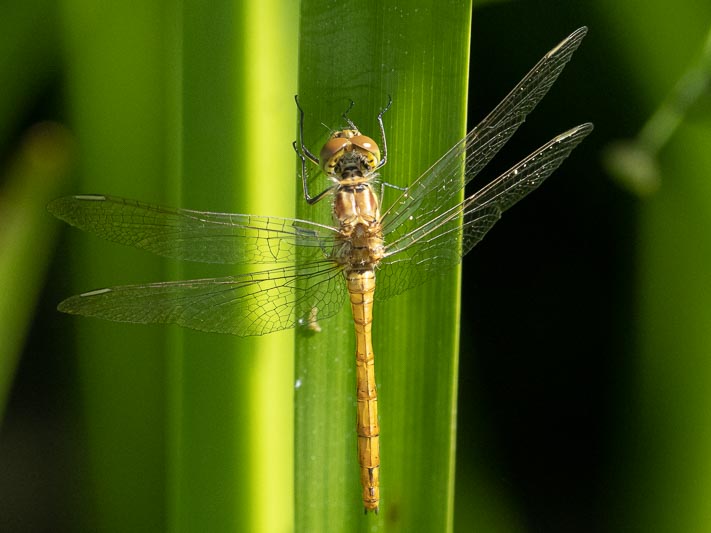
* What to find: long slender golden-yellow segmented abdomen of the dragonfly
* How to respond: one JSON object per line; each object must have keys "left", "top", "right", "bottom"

{"left": 346, "top": 269, "right": 380, "bottom": 513}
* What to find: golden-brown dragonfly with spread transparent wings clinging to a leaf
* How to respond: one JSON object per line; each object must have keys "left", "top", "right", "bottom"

{"left": 48, "top": 27, "right": 593, "bottom": 513}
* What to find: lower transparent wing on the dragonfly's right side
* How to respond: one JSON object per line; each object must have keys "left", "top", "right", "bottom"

{"left": 375, "top": 124, "right": 593, "bottom": 299}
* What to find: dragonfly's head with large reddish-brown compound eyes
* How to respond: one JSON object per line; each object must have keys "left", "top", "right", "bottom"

{"left": 320, "top": 130, "right": 380, "bottom": 179}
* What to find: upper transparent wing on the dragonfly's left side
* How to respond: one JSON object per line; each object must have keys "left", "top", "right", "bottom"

{"left": 47, "top": 195, "right": 338, "bottom": 264}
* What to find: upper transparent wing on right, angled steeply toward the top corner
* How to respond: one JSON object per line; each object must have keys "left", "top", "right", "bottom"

{"left": 383, "top": 27, "right": 587, "bottom": 241}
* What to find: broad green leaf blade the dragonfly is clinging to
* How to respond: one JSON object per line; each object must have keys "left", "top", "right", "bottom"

{"left": 296, "top": 2, "right": 471, "bottom": 532}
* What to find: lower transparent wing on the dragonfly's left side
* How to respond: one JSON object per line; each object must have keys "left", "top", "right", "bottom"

{"left": 58, "top": 261, "right": 346, "bottom": 336}
